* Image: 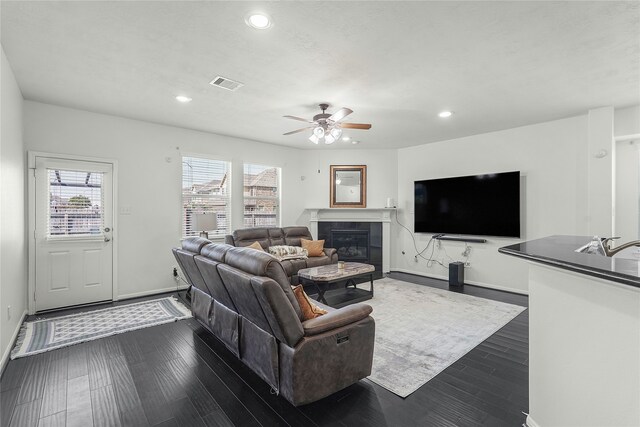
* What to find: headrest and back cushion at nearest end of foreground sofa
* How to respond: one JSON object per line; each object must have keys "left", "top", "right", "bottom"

{"left": 225, "top": 248, "right": 302, "bottom": 320}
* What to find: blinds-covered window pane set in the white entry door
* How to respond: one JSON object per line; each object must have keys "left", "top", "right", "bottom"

{"left": 47, "top": 169, "right": 104, "bottom": 237}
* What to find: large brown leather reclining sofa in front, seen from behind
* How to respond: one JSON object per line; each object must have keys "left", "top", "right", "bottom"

{"left": 173, "top": 238, "right": 375, "bottom": 406}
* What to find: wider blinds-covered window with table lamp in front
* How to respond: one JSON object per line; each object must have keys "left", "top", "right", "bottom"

{"left": 182, "top": 157, "right": 231, "bottom": 239}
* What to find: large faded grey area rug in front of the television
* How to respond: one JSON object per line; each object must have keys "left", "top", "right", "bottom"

{"left": 365, "top": 278, "right": 525, "bottom": 397}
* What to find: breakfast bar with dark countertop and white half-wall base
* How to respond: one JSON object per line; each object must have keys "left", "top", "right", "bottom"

{"left": 499, "top": 236, "right": 640, "bottom": 427}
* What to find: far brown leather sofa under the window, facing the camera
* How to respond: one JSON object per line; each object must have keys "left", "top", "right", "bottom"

{"left": 225, "top": 226, "right": 338, "bottom": 285}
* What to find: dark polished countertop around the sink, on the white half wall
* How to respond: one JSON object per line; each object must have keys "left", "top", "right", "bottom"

{"left": 498, "top": 236, "right": 640, "bottom": 288}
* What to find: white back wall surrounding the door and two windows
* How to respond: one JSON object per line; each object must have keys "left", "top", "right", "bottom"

{"left": 24, "top": 101, "right": 307, "bottom": 298}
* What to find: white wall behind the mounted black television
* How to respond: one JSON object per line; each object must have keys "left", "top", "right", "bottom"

{"left": 392, "top": 116, "right": 588, "bottom": 292}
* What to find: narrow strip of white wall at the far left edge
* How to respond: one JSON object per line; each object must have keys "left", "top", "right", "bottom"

{"left": 0, "top": 49, "right": 27, "bottom": 368}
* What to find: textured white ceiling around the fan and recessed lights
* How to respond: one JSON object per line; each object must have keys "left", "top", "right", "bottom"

{"left": 0, "top": 1, "right": 640, "bottom": 149}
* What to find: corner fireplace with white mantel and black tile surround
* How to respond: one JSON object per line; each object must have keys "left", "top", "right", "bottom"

{"left": 309, "top": 208, "right": 393, "bottom": 278}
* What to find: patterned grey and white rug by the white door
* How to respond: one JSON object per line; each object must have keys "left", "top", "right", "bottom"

{"left": 11, "top": 297, "right": 192, "bottom": 359}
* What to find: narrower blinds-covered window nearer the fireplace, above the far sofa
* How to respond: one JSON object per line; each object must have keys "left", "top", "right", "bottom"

{"left": 244, "top": 163, "right": 280, "bottom": 231}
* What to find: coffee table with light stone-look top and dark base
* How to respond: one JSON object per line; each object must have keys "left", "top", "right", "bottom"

{"left": 298, "top": 262, "right": 375, "bottom": 308}
